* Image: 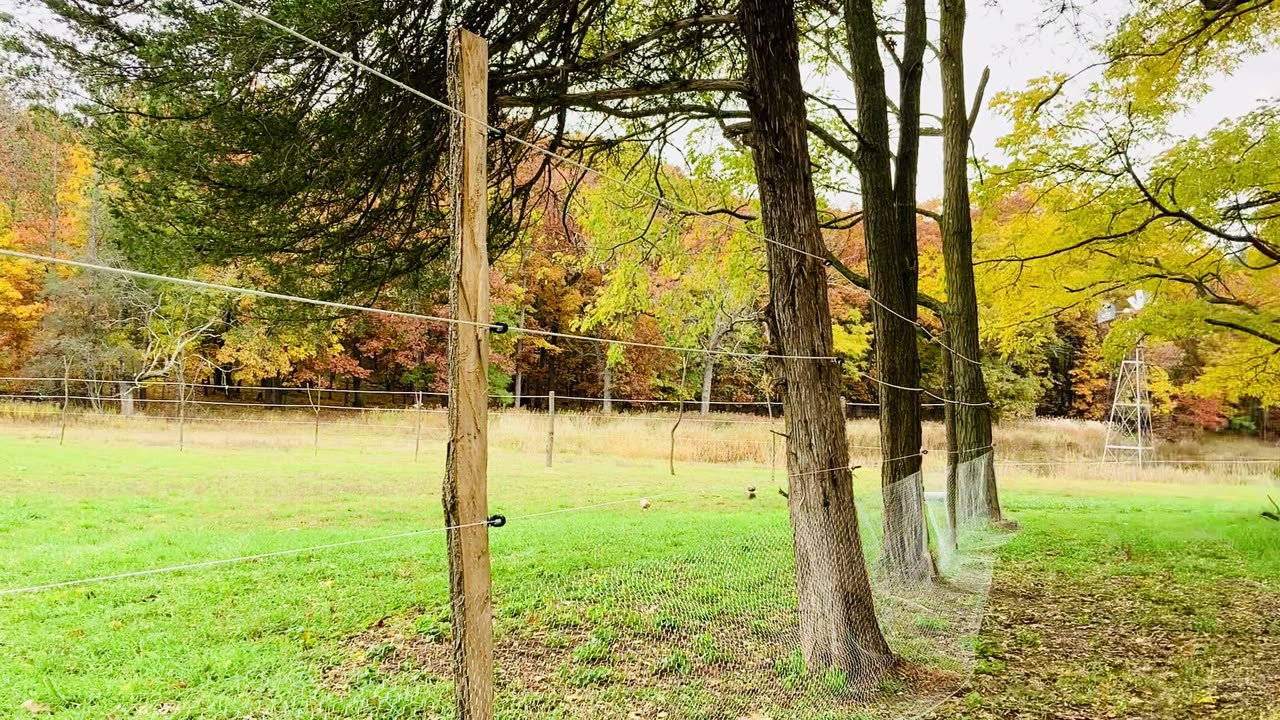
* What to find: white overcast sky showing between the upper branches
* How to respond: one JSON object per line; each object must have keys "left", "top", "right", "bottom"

{"left": 809, "top": 0, "right": 1280, "bottom": 205}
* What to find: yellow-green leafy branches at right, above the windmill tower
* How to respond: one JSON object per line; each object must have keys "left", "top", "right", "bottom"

{"left": 983, "top": 0, "right": 1280, "bottom": 404}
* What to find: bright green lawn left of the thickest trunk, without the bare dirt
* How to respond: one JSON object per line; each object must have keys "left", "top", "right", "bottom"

{"left": 0, "top": 437, "right": 808, "bottom": 717}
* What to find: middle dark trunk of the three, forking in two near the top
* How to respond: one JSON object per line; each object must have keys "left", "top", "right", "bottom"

{"left": 845, "top": 0, "right": 934, "bottom": 582}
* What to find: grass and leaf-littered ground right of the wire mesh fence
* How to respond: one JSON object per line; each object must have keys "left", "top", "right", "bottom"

{"left": 929, "top": 471, "right": 1280, "bottom": 720}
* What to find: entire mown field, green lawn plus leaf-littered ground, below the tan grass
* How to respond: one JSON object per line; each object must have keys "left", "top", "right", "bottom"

{"left": 0, "top": 419, "right": 1280, "bottom": 719}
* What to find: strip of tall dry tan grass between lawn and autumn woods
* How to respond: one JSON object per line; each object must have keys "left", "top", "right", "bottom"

{"left": 0, "top": 402, "right": 1280, "bottom": 484}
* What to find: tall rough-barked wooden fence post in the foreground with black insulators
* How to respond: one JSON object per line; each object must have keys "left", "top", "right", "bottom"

{"left": 443, "top": 28, "right": 493, "bottom": 720}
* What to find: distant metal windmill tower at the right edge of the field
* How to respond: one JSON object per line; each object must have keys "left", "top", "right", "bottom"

{"left": 1098, "top": 290, "right": 1153, "bottom": 468}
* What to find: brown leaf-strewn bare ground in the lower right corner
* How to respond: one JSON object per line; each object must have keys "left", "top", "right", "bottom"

{"left": 928, "top": 568, "right": 1280, "bottom": 720}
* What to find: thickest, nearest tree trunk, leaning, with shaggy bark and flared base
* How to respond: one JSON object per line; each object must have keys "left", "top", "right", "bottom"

{"left": 741, "top": 0, "right": 893, "bottom": 687}
